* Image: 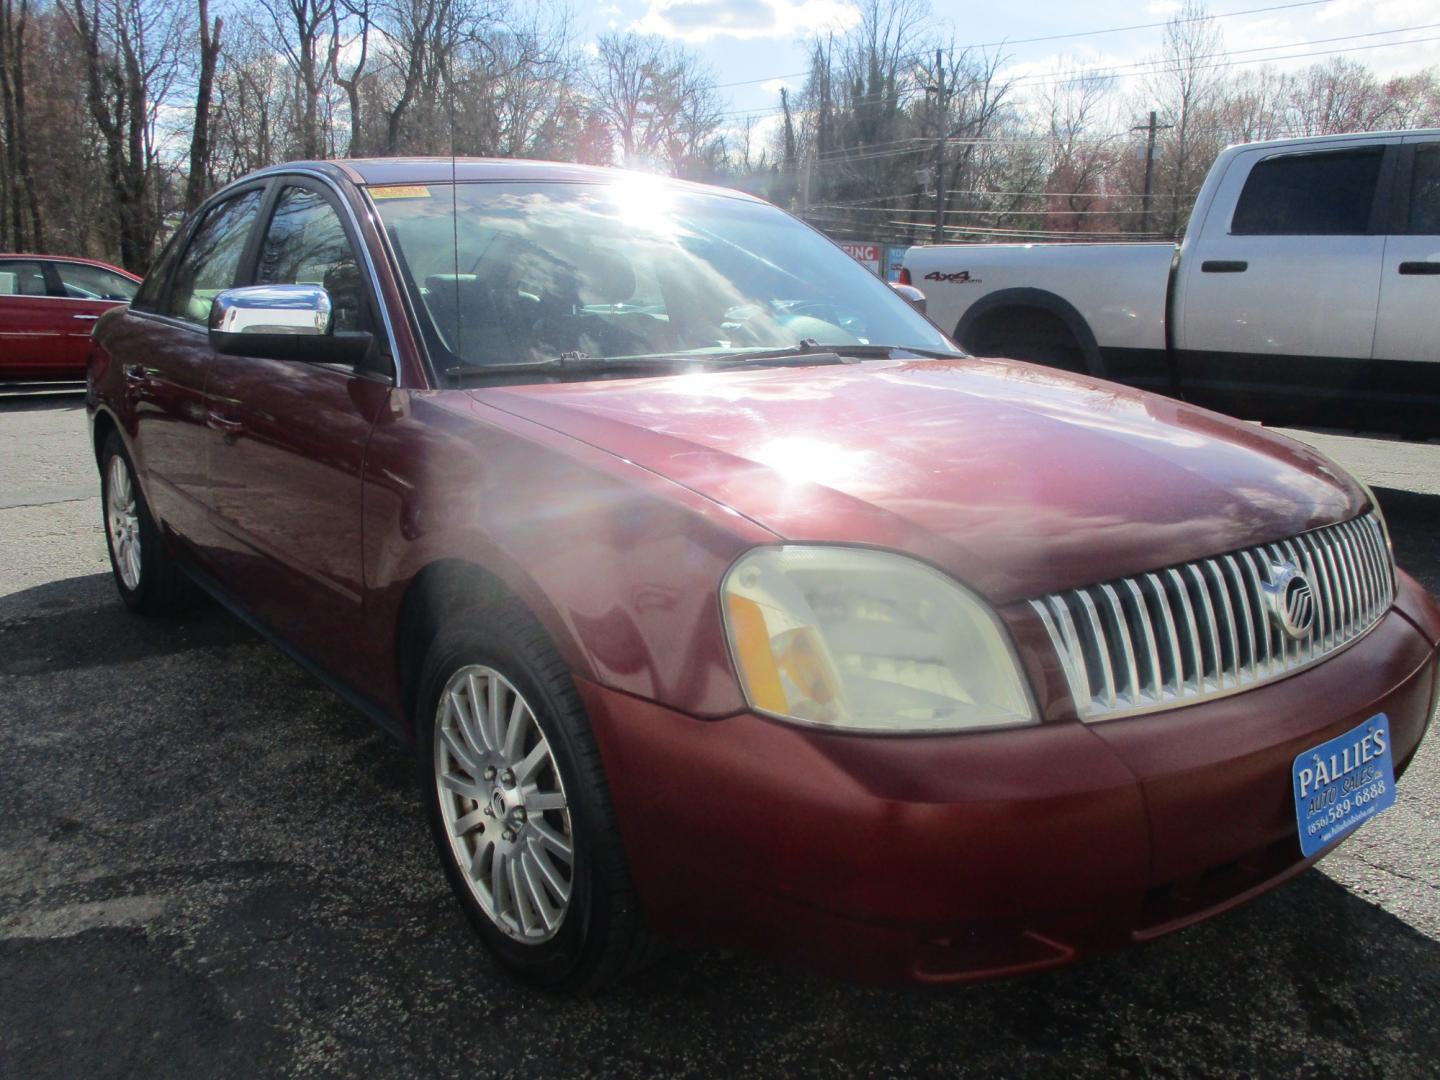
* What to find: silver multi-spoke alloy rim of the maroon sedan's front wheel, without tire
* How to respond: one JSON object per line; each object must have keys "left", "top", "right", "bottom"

{"left": 435, "top": 664, "right": 575, "bottom": 945}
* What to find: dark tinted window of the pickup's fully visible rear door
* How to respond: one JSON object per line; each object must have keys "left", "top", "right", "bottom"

{"left": 1230, "top": 147, "right": 1385, "bottom": 236}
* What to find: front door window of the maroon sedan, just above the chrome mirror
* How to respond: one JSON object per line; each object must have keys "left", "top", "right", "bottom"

{"left": 255, "top": 187, "right": 364, "bottom": 330}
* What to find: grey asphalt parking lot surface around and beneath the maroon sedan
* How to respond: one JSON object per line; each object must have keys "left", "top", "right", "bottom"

{"left": 0, "top": 399, "right": 1440, "bottom": 1077}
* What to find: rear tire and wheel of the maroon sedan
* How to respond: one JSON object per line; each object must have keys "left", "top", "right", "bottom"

{"left": 99, "top": 431, "right": 196, "bottom": 615}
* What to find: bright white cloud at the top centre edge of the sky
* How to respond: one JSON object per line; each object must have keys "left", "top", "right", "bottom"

{"left": 631, "top": 0, "right": 860, "bottom": 43}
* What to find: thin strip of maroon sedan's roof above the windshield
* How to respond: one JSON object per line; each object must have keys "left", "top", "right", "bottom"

{"left": 243, "top": 157, "right": 763, "bottom": 202}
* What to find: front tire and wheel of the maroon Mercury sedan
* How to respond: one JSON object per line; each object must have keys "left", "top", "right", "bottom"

{"left": 416, "top": 602, "right": 654, "bottom": 991}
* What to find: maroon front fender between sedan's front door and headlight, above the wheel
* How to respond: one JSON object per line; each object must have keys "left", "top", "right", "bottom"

{"left": 364, "top": 392, "right": 775, "bottom": 728}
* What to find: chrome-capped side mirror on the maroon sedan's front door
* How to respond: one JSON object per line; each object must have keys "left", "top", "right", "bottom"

{"left": 209, "top": 285, "right": 373, "bottom": 366}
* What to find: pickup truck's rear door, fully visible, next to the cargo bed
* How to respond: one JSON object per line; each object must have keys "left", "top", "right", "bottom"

{"left": 1175, "top": 140, "right": 1388, "bottom": 422}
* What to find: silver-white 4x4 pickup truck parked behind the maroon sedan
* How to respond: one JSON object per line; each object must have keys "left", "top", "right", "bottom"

{"left": 901, "top": 130, "right": 1440, "bottom": 435}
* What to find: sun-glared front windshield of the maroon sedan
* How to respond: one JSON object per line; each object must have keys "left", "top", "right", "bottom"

{"left": 370, "top": 174, "right": 958, "bottom": 376}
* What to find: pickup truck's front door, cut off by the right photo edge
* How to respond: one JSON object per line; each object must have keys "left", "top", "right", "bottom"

{"left": 1375, "top": 135, "right": 1440, "bottom": 365}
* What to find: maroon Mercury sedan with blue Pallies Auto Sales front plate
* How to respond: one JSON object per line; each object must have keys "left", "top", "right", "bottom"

{"left": 88, "top": 160, "right": 1440, "bottom": 988}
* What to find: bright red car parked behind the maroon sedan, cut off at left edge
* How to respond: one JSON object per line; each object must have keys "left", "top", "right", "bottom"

{"left": 0, "top": 255, "right": 140, "bottom": 379}
